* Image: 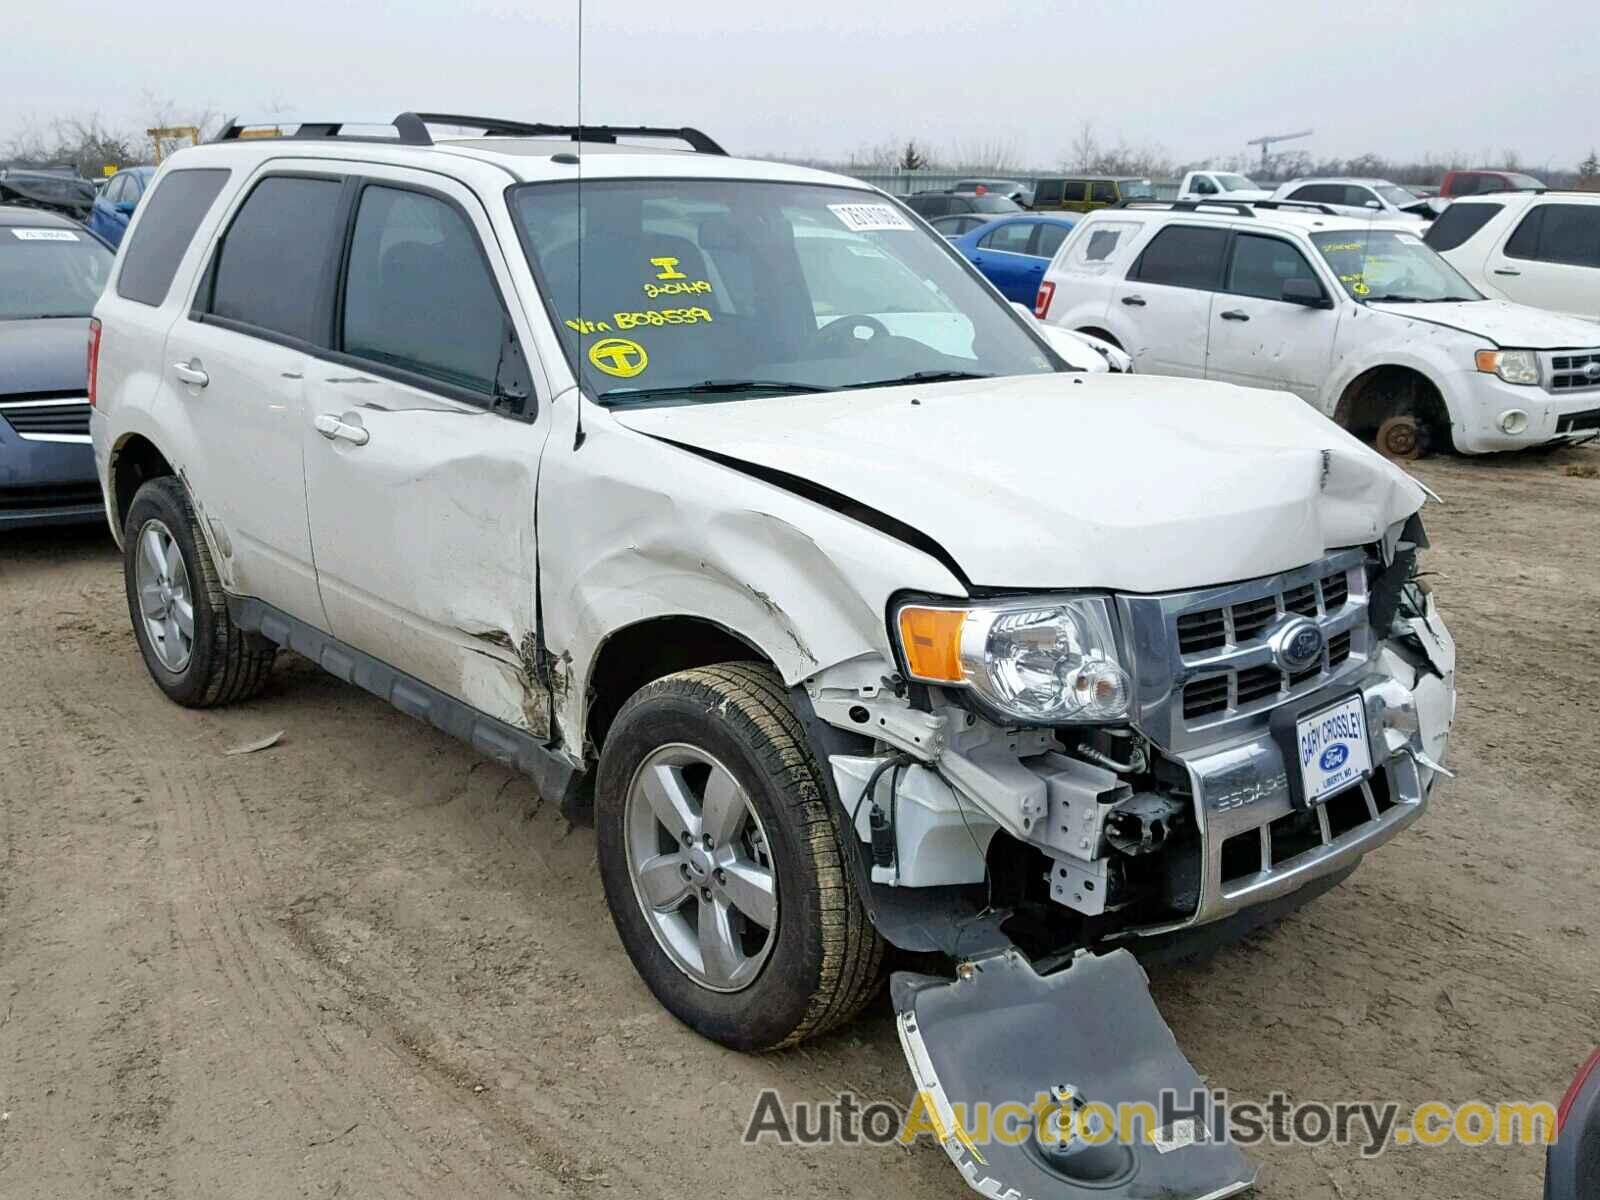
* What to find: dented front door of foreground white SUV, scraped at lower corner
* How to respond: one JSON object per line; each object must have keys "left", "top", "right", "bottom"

{"left": 301, "top": 166, "right": 558, "bottom": 734}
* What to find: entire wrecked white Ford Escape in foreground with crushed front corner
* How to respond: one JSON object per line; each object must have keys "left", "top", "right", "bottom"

{"left": 90, "top": 114, "right": 1454, "bottom": 1197}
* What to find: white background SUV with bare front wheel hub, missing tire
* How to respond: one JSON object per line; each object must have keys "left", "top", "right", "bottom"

{"left": 1035, "top": 202, "right": 1600, "bottom": 459}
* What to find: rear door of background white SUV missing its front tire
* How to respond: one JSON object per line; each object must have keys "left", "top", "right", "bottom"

{"left": 1107, "top": 224, "right": 1227, "bottom": 379}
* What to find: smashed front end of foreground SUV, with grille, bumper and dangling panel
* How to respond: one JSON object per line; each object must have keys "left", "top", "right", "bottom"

{"left": 806, "top": 515, "right": 1456, "bottom": 1197}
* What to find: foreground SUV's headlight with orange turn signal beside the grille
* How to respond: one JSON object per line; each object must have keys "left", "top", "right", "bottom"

{"left": 894, "top": 597, "right": 1133, "bottom": 725}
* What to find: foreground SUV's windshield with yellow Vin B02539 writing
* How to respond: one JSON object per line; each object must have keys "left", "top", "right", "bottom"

{"left": 510, "top": 179, "right": 1061, "bottom": 403}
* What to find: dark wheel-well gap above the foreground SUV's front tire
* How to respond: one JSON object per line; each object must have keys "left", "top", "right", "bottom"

{"left": 586, "top": 616, "right": 771, "bottom": 754}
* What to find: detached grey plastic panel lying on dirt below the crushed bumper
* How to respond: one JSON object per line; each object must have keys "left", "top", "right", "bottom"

{"left": 891, "top": 949, "right": 1256, "bottom": 1200}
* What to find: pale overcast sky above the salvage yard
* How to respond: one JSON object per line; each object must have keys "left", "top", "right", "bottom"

{"left": 12, "top": 0, "right": 1600, "bottom": 166}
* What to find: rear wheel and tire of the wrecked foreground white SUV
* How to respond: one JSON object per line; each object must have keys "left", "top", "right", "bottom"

{"left": 123, "top": 475, "right": 277, "bottom": 709}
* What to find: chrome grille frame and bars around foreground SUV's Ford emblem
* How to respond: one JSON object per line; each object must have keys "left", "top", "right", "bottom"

{"left": 1117, "top": 549, "right": 1373, "bottom": 750}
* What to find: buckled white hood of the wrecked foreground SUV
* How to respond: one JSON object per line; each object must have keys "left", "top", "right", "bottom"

{"left": 614, "top": 374, "right": 1424, "bottom": 592}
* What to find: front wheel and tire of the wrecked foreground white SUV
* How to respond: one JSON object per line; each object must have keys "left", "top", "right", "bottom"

{"left": 595, "top": 662, "right": 883, "bottom": 1050}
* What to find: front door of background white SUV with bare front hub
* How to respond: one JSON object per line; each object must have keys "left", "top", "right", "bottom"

{"left": 1206, "top": 232, "right": 1339, "bottom": 403}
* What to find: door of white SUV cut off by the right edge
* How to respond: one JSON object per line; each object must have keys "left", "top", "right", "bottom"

{"left": 1486, "top": 202, "right": 1600, "bottom": 320}
